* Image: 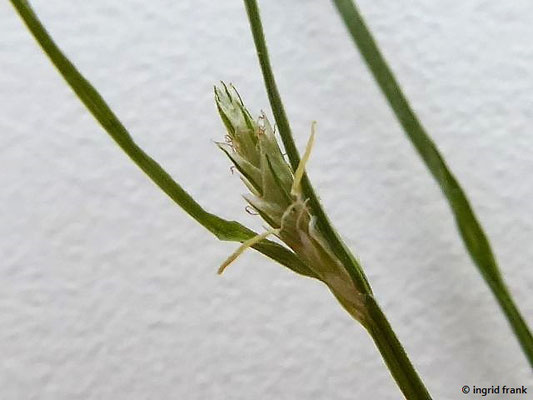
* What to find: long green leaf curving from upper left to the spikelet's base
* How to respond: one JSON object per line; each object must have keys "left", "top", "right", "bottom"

{"left": 11, "top": 0, "right": 316, "bottom": 277}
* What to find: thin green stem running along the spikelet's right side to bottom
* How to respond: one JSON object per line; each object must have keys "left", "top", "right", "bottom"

{"left": 244, "top": 0, "right": 431, "bottom": 400}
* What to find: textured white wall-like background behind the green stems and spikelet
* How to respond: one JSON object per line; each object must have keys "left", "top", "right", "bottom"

{"left": 0, "top": 0, "right": 533, "bottom": 400}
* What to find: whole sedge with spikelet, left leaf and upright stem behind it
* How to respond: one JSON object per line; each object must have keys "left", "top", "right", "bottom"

{"left": 11, "top": 0, "right": 431, "bottom": 399}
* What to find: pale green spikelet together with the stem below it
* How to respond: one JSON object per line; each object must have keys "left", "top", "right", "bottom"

{"left": 215, "top": 85, "right": 431, "bottom": 399}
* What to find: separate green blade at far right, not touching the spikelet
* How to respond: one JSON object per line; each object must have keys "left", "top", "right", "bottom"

{"left": 333, "top": 0, "right": 533, "bottom": 366}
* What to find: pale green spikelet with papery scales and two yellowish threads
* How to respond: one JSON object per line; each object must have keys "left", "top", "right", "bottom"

{"left": 215, "top": 83, "right": 364, "bottom": 320}
